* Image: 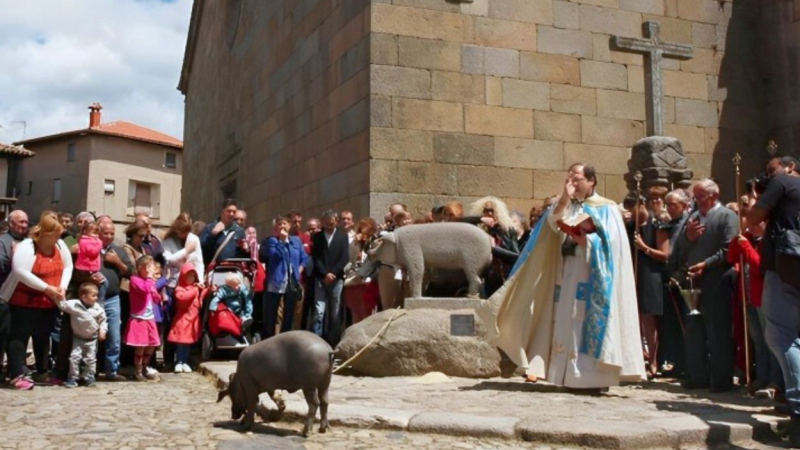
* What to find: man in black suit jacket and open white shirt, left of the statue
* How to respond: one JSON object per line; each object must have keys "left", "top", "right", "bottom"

{"left": 311, "top": 210, "right": 350, "bottom": 347}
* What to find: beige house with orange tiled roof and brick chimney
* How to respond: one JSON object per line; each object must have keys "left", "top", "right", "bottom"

{"left": 13, "top": 103, "right": 183, "bottom": 229}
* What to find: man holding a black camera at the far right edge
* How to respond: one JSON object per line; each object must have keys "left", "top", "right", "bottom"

{"left": 747, "top": 157, "right": 800, "bottom": 448}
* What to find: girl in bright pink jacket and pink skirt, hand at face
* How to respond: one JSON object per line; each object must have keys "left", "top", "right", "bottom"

{"left": 125, "top": 256, "right": 161, "bottom": 381}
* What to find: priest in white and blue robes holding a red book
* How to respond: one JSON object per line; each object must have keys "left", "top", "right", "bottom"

{"left": 481, "top": 163, "right": 646, "bottom": 389}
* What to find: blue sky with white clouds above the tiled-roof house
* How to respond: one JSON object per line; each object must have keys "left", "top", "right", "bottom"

{"left": 0, "top": 0, "right": 192, "bottom": 144}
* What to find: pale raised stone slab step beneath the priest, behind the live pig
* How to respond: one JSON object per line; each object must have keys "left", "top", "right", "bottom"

{"left": 200, "top": 362, "right": 787, "bottom": 449}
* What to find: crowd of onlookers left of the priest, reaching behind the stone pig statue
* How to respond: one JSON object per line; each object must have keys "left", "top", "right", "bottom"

{"left": 0, "top": 186, "right": 541, "bottom": 390}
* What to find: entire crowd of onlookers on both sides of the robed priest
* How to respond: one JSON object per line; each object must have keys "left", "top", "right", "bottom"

{"left": 0, "top": 157, "right": 800, "bottom": 446}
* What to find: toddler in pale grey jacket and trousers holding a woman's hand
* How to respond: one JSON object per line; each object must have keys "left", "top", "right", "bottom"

{"left": 58, "top": 282, "right": 108, "bottom": 388}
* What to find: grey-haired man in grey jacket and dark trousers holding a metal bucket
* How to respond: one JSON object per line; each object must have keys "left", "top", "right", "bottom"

{"left": 669, "top": 179, "right": 739, "bottom": 392}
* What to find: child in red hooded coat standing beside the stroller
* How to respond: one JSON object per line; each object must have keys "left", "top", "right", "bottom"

{"left": 167, "top": 262, "right": 202, "bottom": 373}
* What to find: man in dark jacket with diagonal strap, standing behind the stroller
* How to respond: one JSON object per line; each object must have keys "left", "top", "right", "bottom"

{"left": 200, "top": 198, "right": 245, "bottom": 264}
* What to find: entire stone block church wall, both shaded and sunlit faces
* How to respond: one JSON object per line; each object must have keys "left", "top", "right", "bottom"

{"left": 182, "top": 0, "right": 764, "bottom": 225}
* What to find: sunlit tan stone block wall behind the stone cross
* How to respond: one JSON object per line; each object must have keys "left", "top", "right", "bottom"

{"left": 370, "top": 0, "right": 763, "bottom": 217}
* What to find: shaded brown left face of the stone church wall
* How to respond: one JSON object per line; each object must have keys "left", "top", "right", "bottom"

{"left": 183, "top": 0, "right": 370, "bottom": 232}
